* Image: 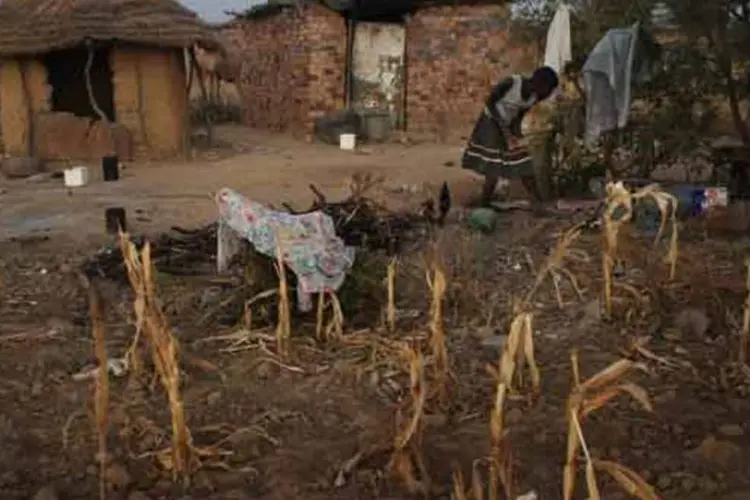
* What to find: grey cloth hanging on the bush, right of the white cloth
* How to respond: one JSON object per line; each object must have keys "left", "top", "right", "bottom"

{"left": 583, "top": 23, "right": 639, "bottom": 146}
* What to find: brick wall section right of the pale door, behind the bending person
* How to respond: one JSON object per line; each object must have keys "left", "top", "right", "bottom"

{"left": 406, "top": 5, "right": 537, "bottom": 140}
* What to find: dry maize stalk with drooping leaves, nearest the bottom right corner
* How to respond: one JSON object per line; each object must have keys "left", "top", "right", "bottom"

{"left": 563, "top": 352, "right": 659, "bottom": 500}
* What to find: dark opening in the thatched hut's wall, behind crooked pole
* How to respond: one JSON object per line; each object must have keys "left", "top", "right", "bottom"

{"left": 44, "top": 47, "right": 115, "bottom": 122}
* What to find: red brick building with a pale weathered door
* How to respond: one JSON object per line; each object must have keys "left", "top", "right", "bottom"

{"left": 222, "top": 0, "right": 538, "bottom": 141}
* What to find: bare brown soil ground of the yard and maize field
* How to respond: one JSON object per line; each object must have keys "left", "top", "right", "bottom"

{"left": 0, "top": 129, "right": 750, "bottom": 500}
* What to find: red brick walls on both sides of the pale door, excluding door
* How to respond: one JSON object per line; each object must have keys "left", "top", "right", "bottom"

{"left": 223, "top": 2, "right": 537, "bottom": 139}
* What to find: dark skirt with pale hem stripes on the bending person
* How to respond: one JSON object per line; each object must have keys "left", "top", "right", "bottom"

{"left": 461, "top": 111, "right": 534, "bottom": 179}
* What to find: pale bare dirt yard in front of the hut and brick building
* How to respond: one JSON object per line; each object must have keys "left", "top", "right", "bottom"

{"left": 0, "top": 127, "right": 478, "bottom": 244}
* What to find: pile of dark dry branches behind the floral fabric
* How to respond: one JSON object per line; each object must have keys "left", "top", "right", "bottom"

{"left": 83, "top": 178, "right": 431, "bottom": 283}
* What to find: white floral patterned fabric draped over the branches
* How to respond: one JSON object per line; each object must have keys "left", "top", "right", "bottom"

{"left": 216, "top": 188, "right": 354, "bottom": 311}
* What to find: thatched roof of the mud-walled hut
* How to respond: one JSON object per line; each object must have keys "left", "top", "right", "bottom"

{"left": 0, "top": 0, "right": 215, "bottom": 57}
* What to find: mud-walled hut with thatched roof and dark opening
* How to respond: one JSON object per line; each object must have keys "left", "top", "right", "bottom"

{"left": 0, "top": 0, "right": 213, "bottom": 161}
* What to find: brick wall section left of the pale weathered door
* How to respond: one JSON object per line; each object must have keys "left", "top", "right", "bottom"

{"left": 222, "top": 4, "right": 347, "bottom": 134}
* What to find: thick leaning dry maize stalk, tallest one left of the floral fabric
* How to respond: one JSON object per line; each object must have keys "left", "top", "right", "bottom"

{"left": 120, "top": 234, "right": 197, "bottom": 482}
